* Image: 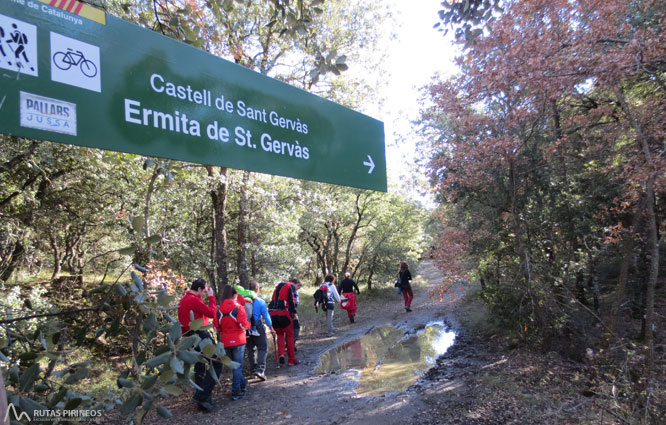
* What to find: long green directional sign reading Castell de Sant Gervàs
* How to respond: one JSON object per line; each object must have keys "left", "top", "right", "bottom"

{"left": 0, "top": 0, "right": 386, "bottom": 191}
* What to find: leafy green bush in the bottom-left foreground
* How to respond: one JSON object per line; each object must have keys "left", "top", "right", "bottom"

{"left": 2, "top": 262, "right": 233, "bottom": 422}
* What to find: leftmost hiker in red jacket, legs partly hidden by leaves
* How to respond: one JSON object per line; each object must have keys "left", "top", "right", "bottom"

{"left": 178, "top": 279, "right": 222, "bottom": 411}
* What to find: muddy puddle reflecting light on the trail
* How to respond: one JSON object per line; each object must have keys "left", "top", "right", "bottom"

{"left": 315, "top": 322, "right": 456, "bottom": 395}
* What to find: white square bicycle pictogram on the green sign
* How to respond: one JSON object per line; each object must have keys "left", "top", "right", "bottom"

{"left": 51, "top": 32, "right": 102, "bottom": 93}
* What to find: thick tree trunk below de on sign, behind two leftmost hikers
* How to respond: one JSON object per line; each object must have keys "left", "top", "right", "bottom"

{"left": 206, "top": 166, "right": 229, "bottom": 292}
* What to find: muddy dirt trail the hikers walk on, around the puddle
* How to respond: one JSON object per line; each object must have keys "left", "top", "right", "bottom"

{"left": 146, "top": 261, "right": 457, "bottom": 425}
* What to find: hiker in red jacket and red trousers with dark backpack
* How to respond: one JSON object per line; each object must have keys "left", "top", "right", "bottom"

{"left": 268, "top": 282, "right": 300, "bottom": 366}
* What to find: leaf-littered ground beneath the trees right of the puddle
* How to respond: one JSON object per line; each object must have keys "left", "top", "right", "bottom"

{"left": 423, "top": 283, "right": 666, "bottom": 425}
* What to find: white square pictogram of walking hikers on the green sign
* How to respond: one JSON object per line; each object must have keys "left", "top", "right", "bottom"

{"left": 0, "top": 15, "right": 38, "bottom": 77}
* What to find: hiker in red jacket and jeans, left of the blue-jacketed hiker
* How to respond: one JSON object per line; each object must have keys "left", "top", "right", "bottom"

{"left": 216, "top": 285, "right": 250, "bottom": 400}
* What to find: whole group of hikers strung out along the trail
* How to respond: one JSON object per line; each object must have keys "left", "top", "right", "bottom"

{"left": 178, "top": 262, "right": 413, "bottom": 411}
